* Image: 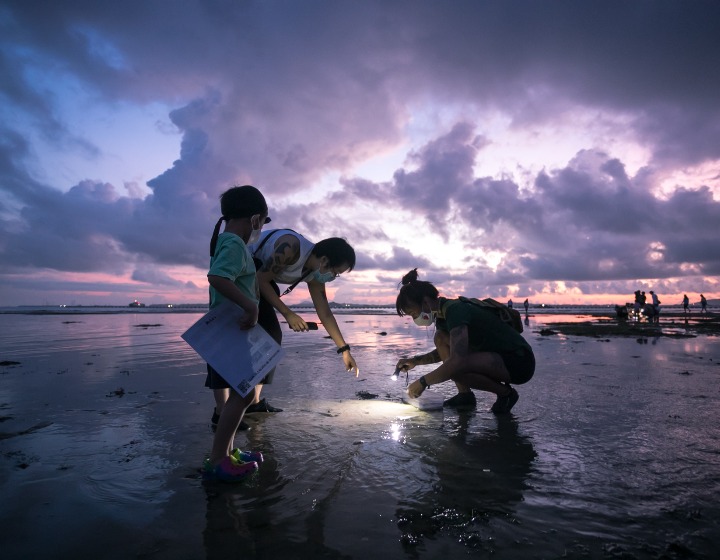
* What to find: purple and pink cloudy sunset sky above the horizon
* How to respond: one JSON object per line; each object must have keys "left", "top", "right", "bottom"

{"left": 0, "top": 0, "right": 720, "bottom": 305}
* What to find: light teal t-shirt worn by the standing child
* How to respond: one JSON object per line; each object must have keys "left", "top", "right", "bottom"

{"left": 208, "top": 233, "right": 260, "bottom": 309}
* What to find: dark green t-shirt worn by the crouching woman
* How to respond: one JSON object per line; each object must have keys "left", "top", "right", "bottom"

{"left": 438, "top": 298, "right": 532, "bottom": 354}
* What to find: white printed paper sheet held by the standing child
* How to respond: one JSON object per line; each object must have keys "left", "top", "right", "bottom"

{"left": 181, "top": 300, "right": 283, "bottom": 397}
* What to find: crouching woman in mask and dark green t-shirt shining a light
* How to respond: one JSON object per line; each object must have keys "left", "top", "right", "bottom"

{"left": 395, "top": 269, "right": 535, "bottom": 414}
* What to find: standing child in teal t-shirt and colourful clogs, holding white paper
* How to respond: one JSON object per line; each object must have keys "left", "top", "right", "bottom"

{"left": 203, "top": 185, "right": 270, "bottom": 482}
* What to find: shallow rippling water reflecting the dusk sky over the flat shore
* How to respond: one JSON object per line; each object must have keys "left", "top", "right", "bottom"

{"left": 0, "top": 313, "right": 720, "bottom": 559}
